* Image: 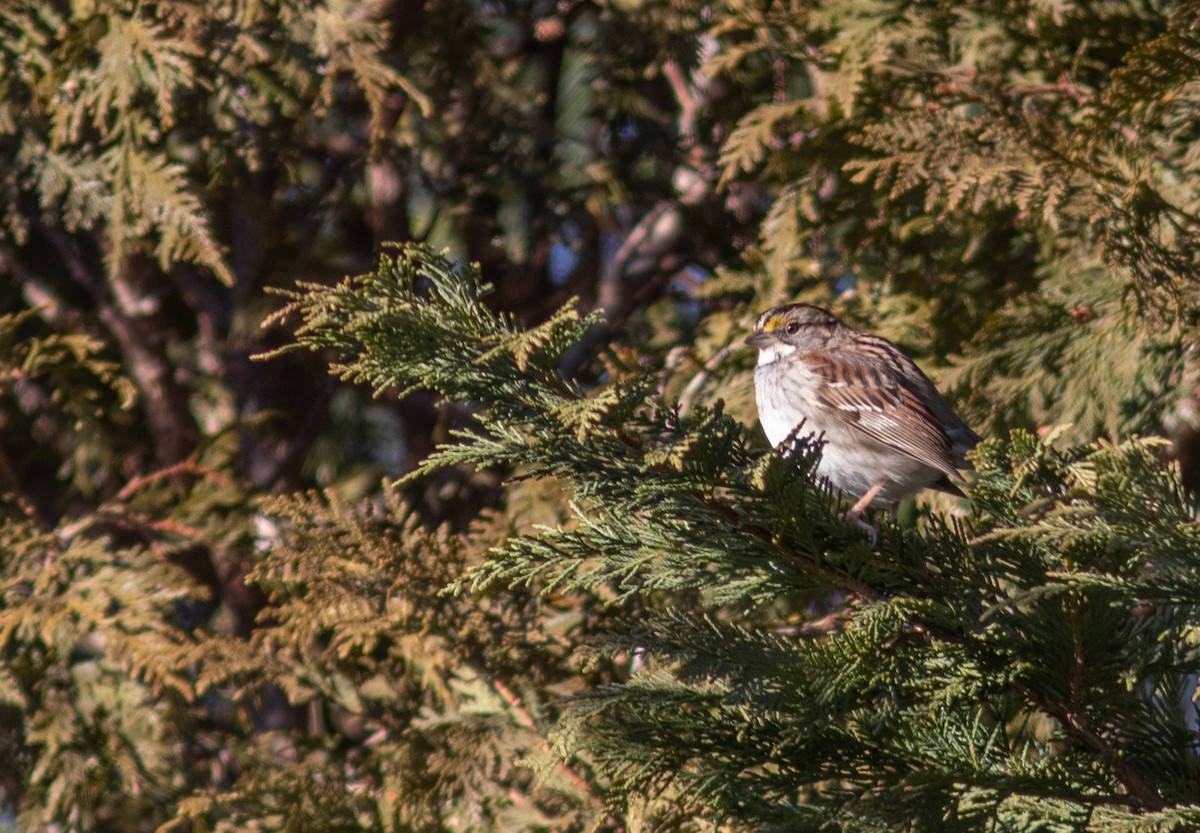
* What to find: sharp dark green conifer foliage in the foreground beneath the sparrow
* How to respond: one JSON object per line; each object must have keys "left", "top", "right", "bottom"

{"left": 270, "top": 247, "right": 1200, "bottom": 831}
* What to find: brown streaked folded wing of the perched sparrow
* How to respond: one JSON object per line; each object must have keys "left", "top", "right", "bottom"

{"left": 803, "top": 336, "right": 959, "bottom": 478}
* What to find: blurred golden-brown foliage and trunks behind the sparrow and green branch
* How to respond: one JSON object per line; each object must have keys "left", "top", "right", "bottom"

{"left": 0, "top": 0, "right": 1200, "bottom": 831}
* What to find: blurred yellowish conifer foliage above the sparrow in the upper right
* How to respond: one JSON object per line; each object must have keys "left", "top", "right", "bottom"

{"left": 701, "top": 1, "right": 1200, "bottom": 451}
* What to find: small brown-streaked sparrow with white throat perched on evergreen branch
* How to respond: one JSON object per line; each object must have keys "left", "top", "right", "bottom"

{"left": 745, "top": 304, "right": 979, "bottom": 528}
